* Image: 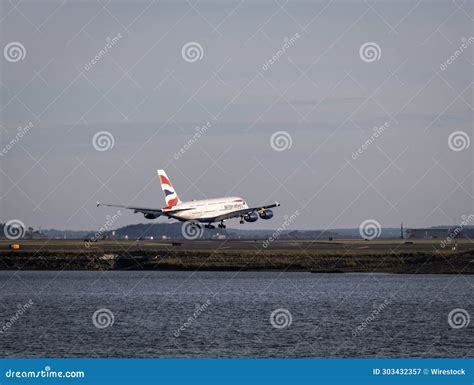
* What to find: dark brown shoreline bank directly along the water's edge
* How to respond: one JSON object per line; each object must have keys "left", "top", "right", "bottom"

{"left": 0, "top": 250, "right": 474, "bottom": 274}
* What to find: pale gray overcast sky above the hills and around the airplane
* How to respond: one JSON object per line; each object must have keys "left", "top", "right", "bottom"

{"left": 0, "top": 0, "right": 474, "bottom": 229}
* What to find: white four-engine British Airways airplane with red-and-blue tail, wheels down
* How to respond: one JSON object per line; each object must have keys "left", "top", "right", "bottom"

{"left": 97, "top": 170, "right": 280, "bottom": 229}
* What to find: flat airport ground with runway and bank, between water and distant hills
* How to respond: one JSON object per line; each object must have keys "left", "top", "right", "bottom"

{"left": 0, "top": 239, "right": 474, "bottom": 274}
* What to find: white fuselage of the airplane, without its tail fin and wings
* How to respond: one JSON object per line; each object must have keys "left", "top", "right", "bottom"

{"left": 167, "top": 197, "right": 249, "bottom": 222}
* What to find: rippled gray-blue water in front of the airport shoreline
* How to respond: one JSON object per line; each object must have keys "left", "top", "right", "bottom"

{"left": 0, "top": 271, "right": 474, "bottom": 357}
